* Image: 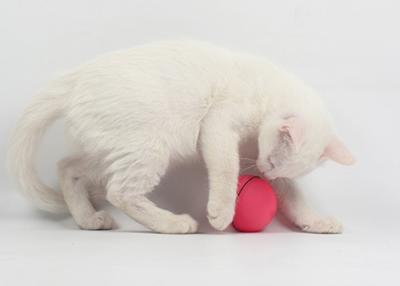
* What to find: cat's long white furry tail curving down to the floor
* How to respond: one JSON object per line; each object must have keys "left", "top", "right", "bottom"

{"left": 8, "top": 75, "right": 76, "bottom": 213}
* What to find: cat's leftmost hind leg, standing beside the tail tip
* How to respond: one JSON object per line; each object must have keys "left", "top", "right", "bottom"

{"left": 58, "top": 156, "right": 113, "bottom": 230}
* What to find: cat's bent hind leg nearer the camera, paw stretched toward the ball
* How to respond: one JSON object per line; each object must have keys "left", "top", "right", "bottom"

{"left": 107, "top": 151, "right": 197, "bottom": 233}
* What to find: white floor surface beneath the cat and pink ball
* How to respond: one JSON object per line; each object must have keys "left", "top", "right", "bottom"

{"left": 0, "top": 190, "right": 400, "bottom": 286}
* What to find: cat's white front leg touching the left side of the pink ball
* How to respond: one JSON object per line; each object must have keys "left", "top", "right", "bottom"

{"left": 200, "top": 111, "right": 239, "bottom": 230}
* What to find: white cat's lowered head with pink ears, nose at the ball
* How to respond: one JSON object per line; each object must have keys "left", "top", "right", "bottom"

{"left": 257, "top": 115, "right": 354, "bottom": 179}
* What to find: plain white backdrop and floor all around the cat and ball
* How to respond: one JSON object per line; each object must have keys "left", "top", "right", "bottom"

{"left": 0, "top": 0, "right": 400, "bottom": 285}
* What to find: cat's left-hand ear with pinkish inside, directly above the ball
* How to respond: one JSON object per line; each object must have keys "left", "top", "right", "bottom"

{"left": 279, "top": 115, "right": 306, "bottom": 151}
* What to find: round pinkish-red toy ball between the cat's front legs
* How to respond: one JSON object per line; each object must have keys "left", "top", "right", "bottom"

{"left": 232, "top": 176, "right": 277, "bottom": 232}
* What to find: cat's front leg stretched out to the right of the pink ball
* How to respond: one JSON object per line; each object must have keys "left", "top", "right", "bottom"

{"left": 271, "top": 179, "right": 342, "bottom": 233}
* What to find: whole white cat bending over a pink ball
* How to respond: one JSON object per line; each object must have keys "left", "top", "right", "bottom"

{"left": 10, "top": 41, "right": 353, "bottom": 233}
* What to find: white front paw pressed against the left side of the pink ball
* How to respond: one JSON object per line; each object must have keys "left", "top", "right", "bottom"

{"left": 207, "top": 202, "right": 235, "bottom": 230}
